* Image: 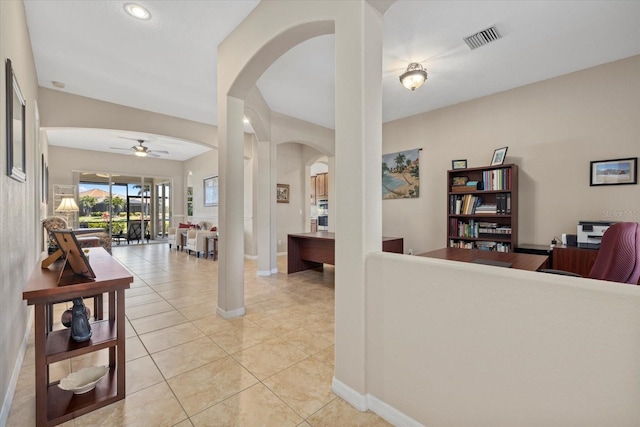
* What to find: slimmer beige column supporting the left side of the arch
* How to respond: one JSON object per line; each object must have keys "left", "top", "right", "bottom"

{"left": 217, "top": 96, "right": 245, "bottom": 318}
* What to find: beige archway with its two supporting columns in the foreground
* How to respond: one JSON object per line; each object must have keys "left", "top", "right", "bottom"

{"left": 218, "top": 0, "right": 392, "bottom": 409}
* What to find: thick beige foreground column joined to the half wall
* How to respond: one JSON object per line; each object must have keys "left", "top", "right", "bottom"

{"left": 333, "top": 1, "right": 382, "bottom": 402}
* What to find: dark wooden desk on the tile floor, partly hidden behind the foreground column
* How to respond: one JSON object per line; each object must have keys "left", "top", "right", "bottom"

{"left": 287, "top": 231, "right": 404, "bottom": 274}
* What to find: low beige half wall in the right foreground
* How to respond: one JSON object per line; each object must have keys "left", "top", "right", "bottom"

{"left": 366, "top": 253, "right": 640, "bottom": 427}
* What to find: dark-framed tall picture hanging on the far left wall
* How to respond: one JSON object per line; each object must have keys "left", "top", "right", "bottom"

{"left": 6, "top": 58, "right": 27, "bottom": 182}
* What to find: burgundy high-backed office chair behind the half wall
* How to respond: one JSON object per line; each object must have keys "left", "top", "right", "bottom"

{"left": 539, "top": 222, "right": 640, "bottom": 285}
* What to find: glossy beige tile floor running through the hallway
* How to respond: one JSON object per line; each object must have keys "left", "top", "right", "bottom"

{"left": 8, "top": 244, "right": 389, "bottom": 427}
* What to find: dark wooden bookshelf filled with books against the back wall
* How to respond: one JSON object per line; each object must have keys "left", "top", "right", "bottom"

{"left": 447, "top": 164, "right": 518, "bottom": 252}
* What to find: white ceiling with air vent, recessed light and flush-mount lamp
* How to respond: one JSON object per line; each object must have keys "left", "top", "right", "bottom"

{"left": 25, "top": 0, "right": 640, "bottom": 159}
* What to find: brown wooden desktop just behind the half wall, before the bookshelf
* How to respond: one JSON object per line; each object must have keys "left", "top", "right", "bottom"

{"left": 418, "top": 248, "right": 549, "bottom": 271}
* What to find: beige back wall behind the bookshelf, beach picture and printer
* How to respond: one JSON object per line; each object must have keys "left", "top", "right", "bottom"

{"left": 382, "top": 56, "right": 640, "bottom": 253}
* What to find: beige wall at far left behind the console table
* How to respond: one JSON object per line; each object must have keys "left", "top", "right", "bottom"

{"left": 0, "top": 1, "right": 40, "bottom": 425}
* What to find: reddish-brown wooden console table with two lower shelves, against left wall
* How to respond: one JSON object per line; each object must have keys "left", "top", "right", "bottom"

{"left": 22, "top": 248, "right": 133, "bottom": 426}
